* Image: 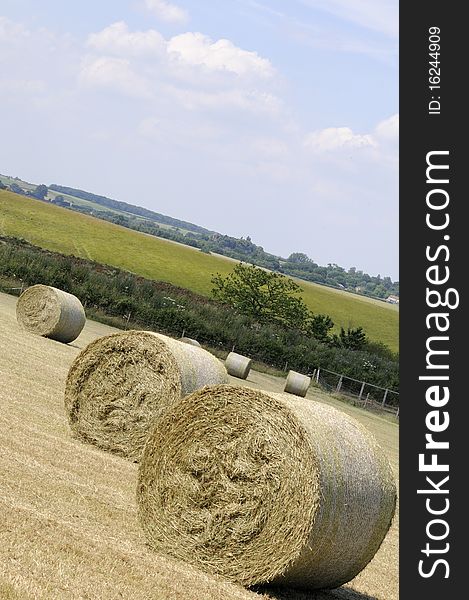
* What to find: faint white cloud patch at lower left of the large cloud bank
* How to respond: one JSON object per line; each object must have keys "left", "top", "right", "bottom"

{"left": 80, "top": 56, "right": 151, "bottom": 98}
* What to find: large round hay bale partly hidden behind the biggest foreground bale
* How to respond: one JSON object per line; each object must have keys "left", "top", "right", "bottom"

{"left": 65, "top": 331, "right": 228, "bottom": 461}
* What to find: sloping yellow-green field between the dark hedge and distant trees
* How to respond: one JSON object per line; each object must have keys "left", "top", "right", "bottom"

{"left": 0, "top": 190, "right": 399, "bottom": 351}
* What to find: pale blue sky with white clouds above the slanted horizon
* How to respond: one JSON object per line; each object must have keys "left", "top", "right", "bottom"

{"left": 0, "top": 0, "right": 399, "bottom": 279}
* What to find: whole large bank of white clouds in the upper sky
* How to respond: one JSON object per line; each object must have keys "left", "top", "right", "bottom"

{"left": 80, "top": 21, "right": 282, "bottom": 116}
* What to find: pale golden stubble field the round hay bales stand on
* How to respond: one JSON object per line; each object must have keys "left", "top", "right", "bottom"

{"left": 0, "top": 294, "right": 398, "bottom": 600}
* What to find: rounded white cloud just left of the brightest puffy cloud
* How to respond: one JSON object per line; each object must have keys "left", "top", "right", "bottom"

{"left": 86, "top": 21, "right": 165, "bottom": 57}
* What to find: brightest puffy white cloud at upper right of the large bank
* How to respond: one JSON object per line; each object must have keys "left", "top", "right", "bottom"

{"left": 168, "top": 32, "right": 274, "bottom": 78}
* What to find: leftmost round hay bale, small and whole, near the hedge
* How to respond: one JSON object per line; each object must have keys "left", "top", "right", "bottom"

{"left": 16, "top": 285, "right": 86, "bottom": 344}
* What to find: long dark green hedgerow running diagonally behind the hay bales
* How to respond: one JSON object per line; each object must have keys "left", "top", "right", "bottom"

{"left": 0, "top": 237, "right": 399, "bottom": 406}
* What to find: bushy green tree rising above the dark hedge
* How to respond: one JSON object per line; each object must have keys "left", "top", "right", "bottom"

{"left": 212, "top": 263, "right": 311, "bottom": 331}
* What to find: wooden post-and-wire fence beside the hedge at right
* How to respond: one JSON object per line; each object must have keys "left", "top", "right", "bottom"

{"left": 309, "top": 368, "right": 399, "bottom": 417}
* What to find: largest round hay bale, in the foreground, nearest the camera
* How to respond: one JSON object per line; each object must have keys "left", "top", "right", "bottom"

{"left": 137, "top": 385, "right": 396, "bottom": 589}
